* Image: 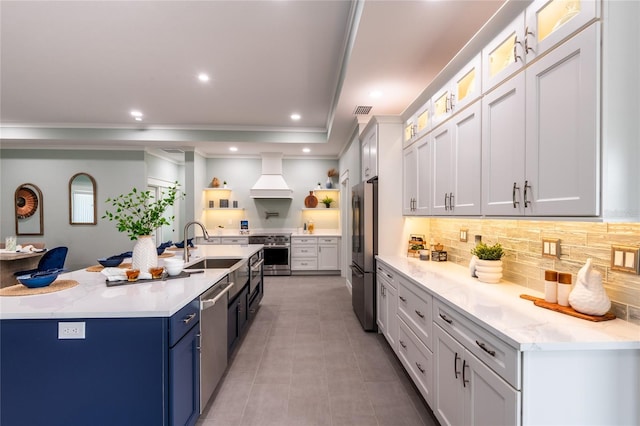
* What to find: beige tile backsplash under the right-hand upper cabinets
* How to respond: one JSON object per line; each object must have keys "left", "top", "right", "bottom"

{"left": 412, "top": 218, "right": 640, "bottom": 324}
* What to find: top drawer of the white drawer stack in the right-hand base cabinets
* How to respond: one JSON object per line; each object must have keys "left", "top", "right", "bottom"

{"left": 396, "top": 275, "right": 433, "bottom": 349}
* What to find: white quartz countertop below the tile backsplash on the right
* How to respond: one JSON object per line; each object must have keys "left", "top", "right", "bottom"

{"left": 378, "top": 255, "right": 640, "bottom": 351}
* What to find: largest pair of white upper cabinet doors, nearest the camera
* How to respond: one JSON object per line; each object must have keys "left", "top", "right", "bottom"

{"left": 482, "top": 24, "right": 599, "bottom": 216}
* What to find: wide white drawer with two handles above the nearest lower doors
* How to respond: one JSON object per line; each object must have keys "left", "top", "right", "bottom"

{"left": 433, "top": 300, "right": 520, "bottom": 389}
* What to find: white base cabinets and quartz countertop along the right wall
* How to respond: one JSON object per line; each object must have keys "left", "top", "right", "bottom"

{"left": 377, "top": 256, "right": 640, "bottom": 425}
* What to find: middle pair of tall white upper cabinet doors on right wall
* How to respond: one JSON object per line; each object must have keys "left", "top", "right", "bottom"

{"left": 430, "top": 102, "right": 481, "bottom": 215}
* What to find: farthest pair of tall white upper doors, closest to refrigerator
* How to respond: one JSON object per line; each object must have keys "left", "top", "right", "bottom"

{"left": 402, "top": 137, "right": 431, "bottom": 216}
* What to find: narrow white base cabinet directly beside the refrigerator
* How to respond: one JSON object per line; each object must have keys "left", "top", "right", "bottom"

{"left": 376, "top": 265, "right": 398, "bottom": 351}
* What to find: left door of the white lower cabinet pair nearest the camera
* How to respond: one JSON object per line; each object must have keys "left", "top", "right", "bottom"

{"left": 433, "top": 325, "right": 466, "bottom": 426}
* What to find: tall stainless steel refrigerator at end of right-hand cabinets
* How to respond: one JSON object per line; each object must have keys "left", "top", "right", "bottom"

{"left": 350, "top": 178, "right": 378, "bottom": 331}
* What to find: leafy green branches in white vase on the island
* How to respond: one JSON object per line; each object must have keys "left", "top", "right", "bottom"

{"left": 102, "top": 182, "right": 184, "bottom": 272}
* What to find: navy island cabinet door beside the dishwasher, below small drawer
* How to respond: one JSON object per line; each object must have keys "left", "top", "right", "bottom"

{"left": 169, "top": 324, "right": 200, "bottom": 425}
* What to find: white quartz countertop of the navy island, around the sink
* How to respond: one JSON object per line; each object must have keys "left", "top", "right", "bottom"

{"left": 0, "top": 244, "right": 263, "bottom": 319}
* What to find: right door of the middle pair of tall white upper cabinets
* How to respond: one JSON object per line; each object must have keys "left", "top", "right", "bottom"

{"left": 449, "top": 101, "right": 482, "bottom": 215}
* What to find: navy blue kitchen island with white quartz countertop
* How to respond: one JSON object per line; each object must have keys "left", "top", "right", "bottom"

{"left": 0, "top": 245, "right": 262, "bottom": 425}
